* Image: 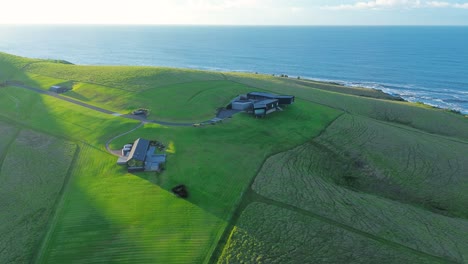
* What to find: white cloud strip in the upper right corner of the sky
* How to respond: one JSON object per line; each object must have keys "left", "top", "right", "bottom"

{"left": 322, "top": 0, "right": 468, "bottom": 10}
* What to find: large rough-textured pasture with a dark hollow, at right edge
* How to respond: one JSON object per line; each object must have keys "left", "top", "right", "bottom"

{"left": 252, "top": 115, "right": 468, "bottom": 262}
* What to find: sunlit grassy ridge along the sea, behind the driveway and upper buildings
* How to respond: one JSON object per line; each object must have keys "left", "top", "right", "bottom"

{"left": 0, "top": 51, "right": 468, "bottom": 133}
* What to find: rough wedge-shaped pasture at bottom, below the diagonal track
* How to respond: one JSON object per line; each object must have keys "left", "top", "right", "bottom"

{"left": 218, "top": 202, "right": 440, "bottom": 264}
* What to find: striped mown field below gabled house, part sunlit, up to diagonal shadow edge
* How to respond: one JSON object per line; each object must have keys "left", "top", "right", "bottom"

{"left": 40, "top": 146, "right": 225, "bottom": 263}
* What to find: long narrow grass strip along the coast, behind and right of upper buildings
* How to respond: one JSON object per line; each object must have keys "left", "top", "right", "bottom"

{"left": 225, "top": 73, "right": 468, "bottom": 141}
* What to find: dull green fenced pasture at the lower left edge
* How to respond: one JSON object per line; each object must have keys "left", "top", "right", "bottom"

{"left": 0, "top": 127, "right": 76, "bottom": 263}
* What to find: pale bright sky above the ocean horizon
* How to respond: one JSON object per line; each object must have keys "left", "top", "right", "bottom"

{"left": 0, "top": 0, "right": 468, "bottom": 25}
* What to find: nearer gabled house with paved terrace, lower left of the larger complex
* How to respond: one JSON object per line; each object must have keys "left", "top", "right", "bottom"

{"left": 121, "top": 138, "right": 167, "bottom": 172}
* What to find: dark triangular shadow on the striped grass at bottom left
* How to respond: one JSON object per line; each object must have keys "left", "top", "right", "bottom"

{"left": 38, "top": 186, "right": 132, "bottom": 263}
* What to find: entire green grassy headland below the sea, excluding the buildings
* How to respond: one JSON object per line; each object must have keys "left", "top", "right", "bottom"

{"left": 0, "top": 53, "right": 468, "bottom": 263}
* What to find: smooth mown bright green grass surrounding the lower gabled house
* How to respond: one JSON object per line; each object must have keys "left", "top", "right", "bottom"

{"left": 0, "top": 84, "right": 339, "bottom": 263}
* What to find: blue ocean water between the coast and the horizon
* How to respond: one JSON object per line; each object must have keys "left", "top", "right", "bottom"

{"left": 0, "top": 25, "right": 468, "bottom": 113}
